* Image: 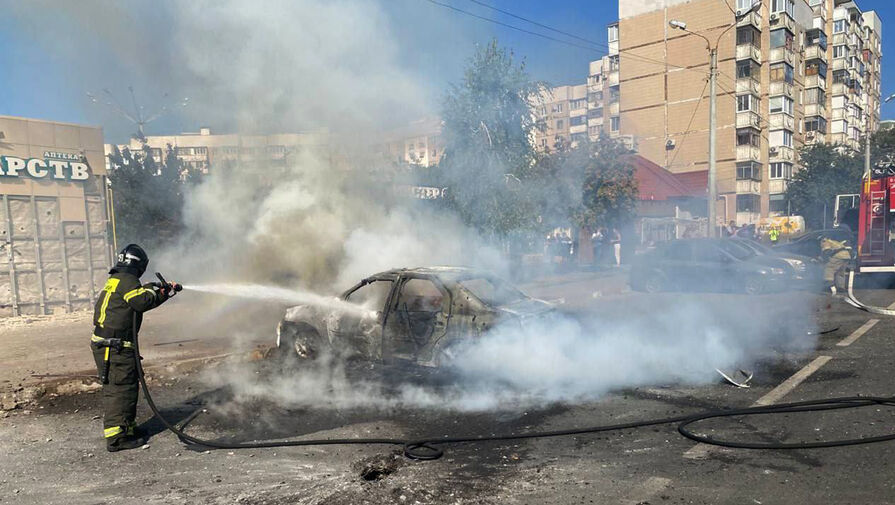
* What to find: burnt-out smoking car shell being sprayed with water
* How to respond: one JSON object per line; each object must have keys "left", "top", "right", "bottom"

{"left": 277, "top": 267, "right": 554, "bottom": 366}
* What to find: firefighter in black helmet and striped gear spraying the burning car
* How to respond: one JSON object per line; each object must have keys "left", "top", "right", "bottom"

{"left": 90, "top": 244, "right": 178, "bottom": 452}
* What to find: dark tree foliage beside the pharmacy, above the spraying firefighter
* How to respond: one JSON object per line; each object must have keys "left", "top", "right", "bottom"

{"left": 109, "top": 145, "right": 197, "bottom": 245}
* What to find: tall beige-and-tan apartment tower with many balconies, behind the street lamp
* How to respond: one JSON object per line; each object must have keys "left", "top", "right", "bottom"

{"left": 616, "top": 0, "right": 881, "bottom": 224}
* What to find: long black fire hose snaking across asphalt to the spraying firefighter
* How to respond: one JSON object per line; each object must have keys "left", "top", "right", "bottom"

{"left": 133, "top": 278, "right": 895, "bottom": 461}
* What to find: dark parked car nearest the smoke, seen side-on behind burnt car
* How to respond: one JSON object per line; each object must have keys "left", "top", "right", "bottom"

{"left": 631, "top": 239, "right": 791, "bottom": 294}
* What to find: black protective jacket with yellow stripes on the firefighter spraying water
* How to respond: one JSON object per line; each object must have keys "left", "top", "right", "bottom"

{"left": 93, "top": 270, "right": 168, "bottom": 340}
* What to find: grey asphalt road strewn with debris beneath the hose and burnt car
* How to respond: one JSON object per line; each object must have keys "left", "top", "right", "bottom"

{"left": 0, "top": 279, "right": 895, "bottom": 505}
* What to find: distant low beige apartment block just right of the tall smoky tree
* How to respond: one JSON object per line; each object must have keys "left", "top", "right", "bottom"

{"left": 534, "top": 84, "right": 588, "bottom": 151}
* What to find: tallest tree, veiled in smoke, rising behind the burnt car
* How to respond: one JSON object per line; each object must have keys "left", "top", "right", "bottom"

{"left": 438, "top": 40, "right": 545, "bottom": 240}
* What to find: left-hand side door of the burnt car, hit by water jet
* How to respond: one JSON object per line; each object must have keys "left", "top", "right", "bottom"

{"left": 327, "top": 278, "right": 395, "bottom": 360}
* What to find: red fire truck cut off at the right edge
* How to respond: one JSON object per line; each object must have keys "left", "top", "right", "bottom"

{"left": 855, "top": 163, "right": 895, "bottom": 273}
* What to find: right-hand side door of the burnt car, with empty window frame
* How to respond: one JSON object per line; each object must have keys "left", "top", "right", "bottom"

{"left": 382, "top": 276, "right": 451, "bottom": 361}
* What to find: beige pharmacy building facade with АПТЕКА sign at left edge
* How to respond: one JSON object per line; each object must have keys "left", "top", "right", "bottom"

{"left": 0, "top": 116, "right": 113, "bottom": 316}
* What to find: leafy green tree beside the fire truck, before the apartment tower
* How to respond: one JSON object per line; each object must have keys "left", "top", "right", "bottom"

{"left": 786, "top": 144, "right": 864, "bottom": 229}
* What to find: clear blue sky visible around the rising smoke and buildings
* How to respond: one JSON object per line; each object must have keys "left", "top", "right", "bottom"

{"left": 0, "top": 0, "right": 895, "bottom": 141}
